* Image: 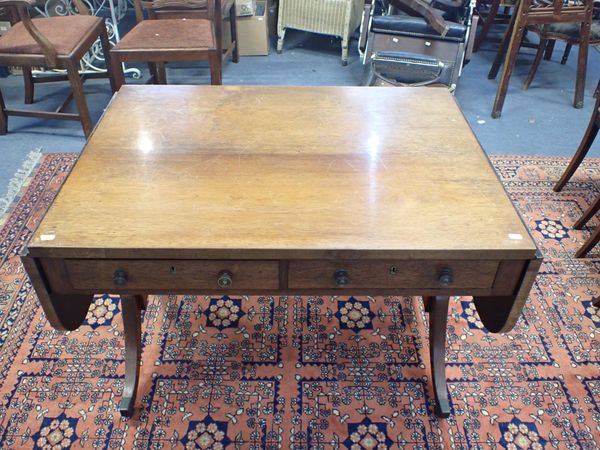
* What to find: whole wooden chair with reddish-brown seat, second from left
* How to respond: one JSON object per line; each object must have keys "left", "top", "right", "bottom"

{"left": 110, "top": 0, "right": 239, "bottom": 89}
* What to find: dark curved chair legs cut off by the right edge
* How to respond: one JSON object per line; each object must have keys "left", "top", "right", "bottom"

{"left": 554, "top": 81, "right": 600, "bottom": 258}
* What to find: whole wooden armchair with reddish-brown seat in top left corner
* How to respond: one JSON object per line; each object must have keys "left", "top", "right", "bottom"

{"left": 0, "top": 0, "right": 115, "bottom": 137}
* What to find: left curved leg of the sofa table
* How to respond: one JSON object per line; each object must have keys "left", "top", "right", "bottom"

{"left": 119, "top": 295, "right": 145, "bottom": 417}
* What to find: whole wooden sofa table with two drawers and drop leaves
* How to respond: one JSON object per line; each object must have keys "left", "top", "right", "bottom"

{"left": 22, "top": 86, "right": 541, "bottom": 417}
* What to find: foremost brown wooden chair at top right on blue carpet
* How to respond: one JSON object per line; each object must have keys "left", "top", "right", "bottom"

{"left": 488, "top": 0, "right": 593, "bottom": 118}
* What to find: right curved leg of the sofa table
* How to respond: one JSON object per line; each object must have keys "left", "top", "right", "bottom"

{"left": 423, "top": 296, "right": 450, "bottom": 418}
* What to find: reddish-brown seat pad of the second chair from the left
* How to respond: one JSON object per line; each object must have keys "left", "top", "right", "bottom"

{"left": 112, "top": 19, "right": 216, "bottom": 52}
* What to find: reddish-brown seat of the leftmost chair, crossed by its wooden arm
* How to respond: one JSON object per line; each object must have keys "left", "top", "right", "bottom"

{"left": 0, "top": 16, "right": 102, "bottom": 56}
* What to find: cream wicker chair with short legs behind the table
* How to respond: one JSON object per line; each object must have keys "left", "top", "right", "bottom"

{"left": 277, "top": 0, "right": 364, "bottom": 66}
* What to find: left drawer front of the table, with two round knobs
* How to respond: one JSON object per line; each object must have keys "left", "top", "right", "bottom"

{"left": 65, "top": 259, "right": 279, "bottom": 291}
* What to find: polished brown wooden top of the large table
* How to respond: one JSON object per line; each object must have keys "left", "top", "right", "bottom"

{"left": 29, "top": 85, "right": 536, "bottom": 259}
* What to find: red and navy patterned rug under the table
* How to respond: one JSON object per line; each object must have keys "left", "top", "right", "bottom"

{"left": 0, "top": 154, "right": 600, "bottom": 450}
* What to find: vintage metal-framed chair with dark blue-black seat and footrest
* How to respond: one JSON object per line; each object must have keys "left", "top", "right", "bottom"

{"left": 359, "top": 0, "right": 472, "bottom": 89}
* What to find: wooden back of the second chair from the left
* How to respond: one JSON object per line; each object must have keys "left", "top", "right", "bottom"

{"left": 135, "top": 0, "right": 222, "bottom": 22}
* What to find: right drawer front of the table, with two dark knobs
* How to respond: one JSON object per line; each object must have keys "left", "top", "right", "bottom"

{"left": 288, "top": 260, "right": 498, "bottom": 289}
